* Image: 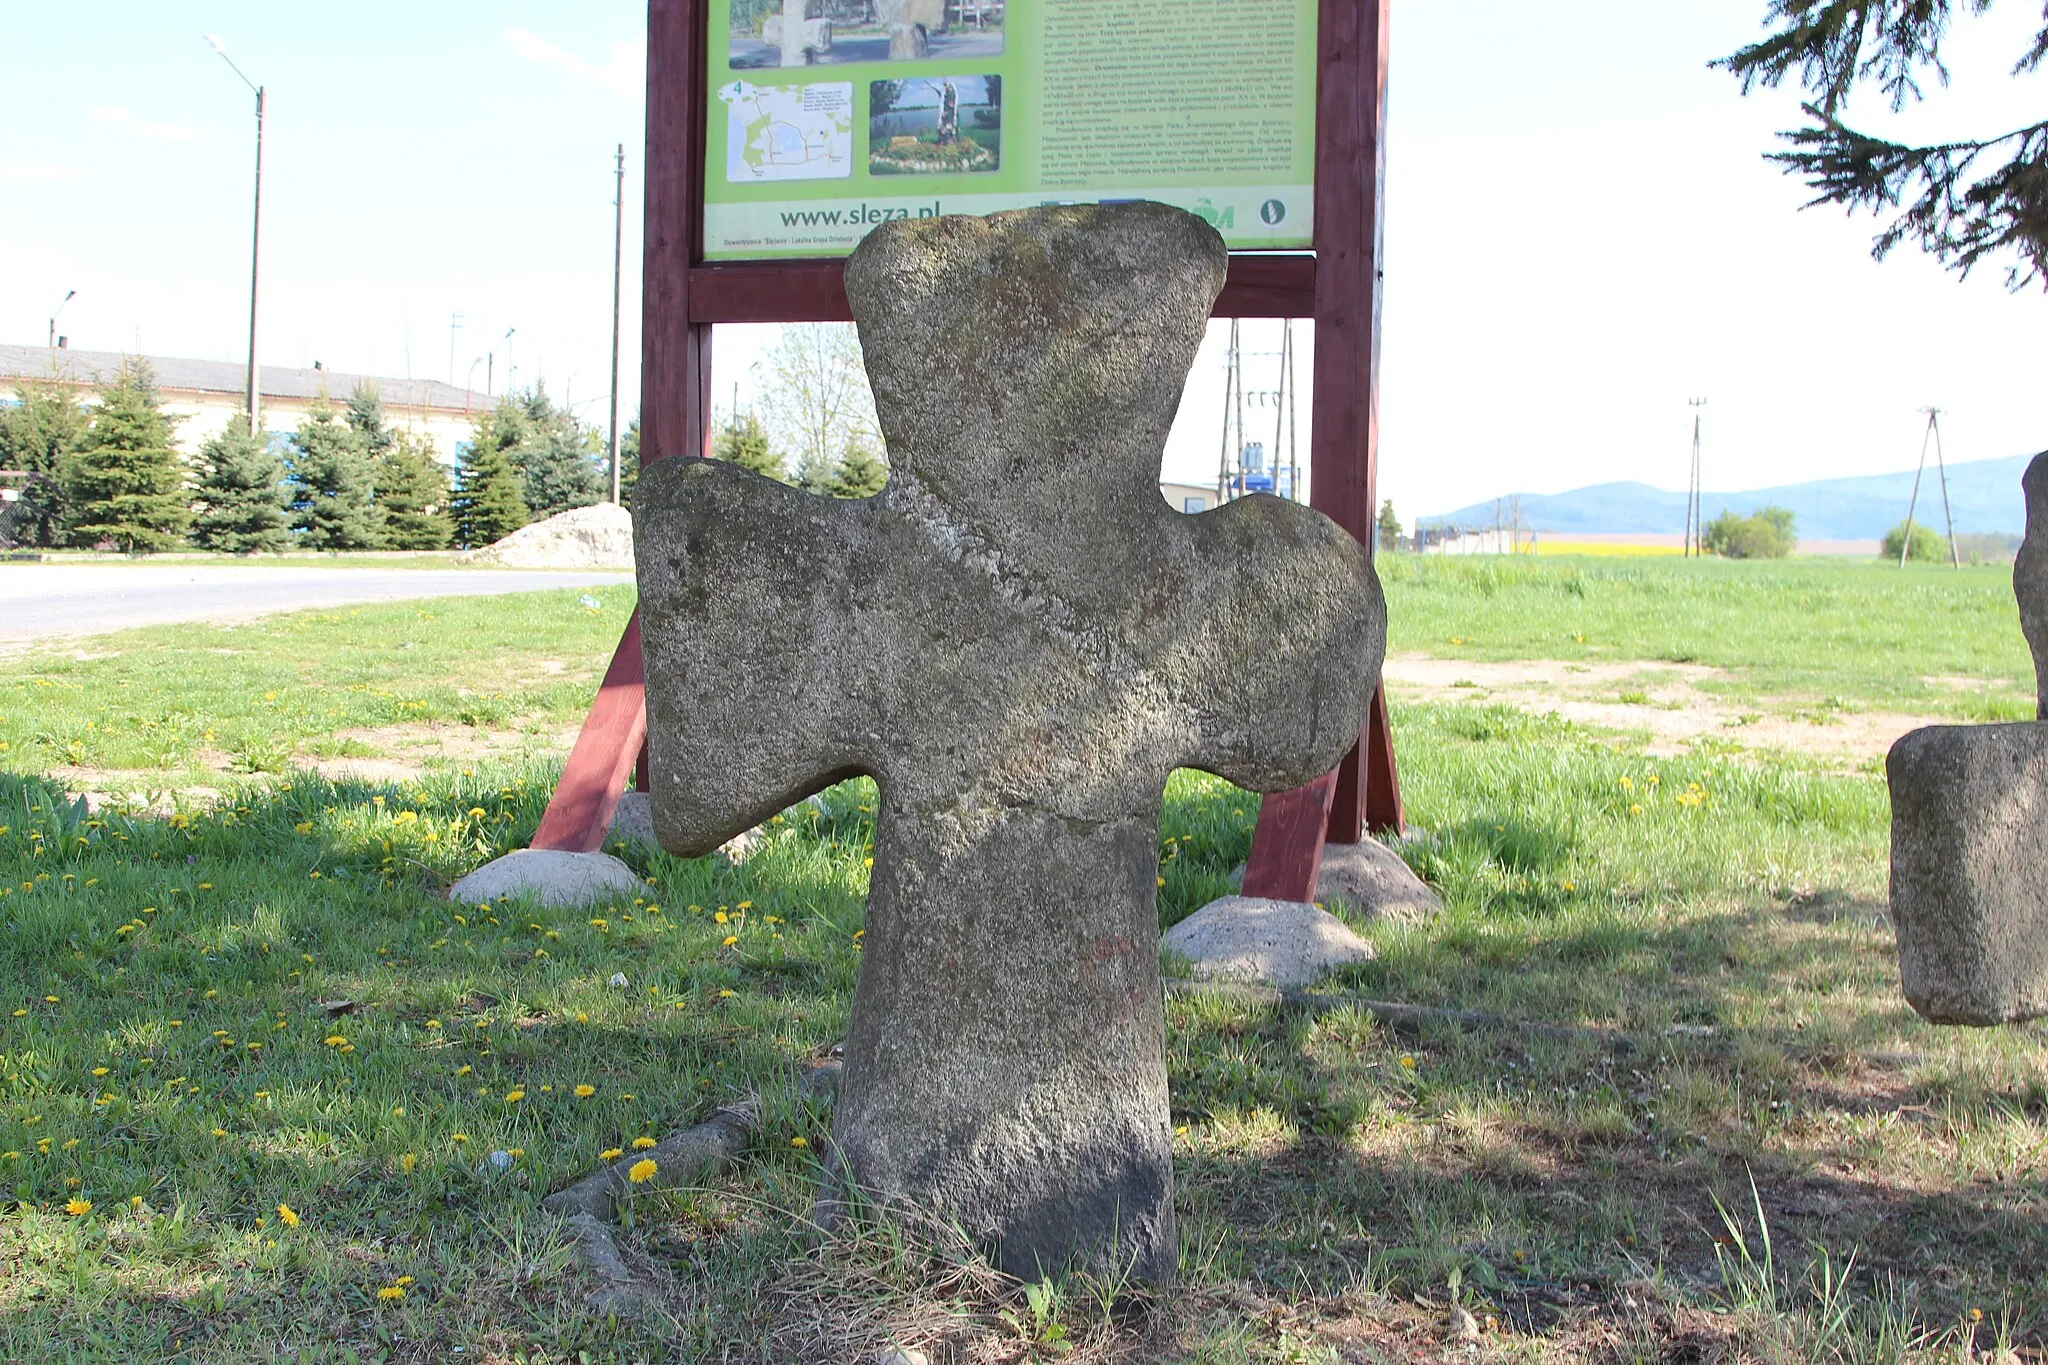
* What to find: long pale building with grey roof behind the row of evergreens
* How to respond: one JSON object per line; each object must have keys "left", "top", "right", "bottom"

{"left": 0, "top": 346, "right": 496, "bottom": 465}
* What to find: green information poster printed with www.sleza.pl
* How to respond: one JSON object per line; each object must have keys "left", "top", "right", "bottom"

{"left": 705, "top": 0, "right": 1317, "bottom": 260}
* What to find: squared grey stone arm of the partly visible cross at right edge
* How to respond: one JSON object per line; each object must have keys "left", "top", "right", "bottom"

{"left": 1884, "top": 722, "right": 2048, "bottom": 1025}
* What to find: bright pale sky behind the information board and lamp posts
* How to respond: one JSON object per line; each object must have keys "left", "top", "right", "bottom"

{"left": 0, "top": 0, "right": 2048, "bottom": 520}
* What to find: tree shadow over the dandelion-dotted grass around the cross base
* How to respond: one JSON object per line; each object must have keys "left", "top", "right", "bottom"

{"left": 0, "top": 769, "right": 2048, "bottom": 1351}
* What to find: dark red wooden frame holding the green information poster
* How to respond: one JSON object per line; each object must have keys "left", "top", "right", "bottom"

{"left": 532, "top": 0, "right": 1401, "bottom": 900}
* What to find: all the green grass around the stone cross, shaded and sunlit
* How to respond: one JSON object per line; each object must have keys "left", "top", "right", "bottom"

{"left": 0, "top": 563, "right": 2048, "bottom": 1363}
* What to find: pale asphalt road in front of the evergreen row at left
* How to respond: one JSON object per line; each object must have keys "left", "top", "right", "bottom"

{"left": 0, "top": 565, "right": 633, "bottom": 645}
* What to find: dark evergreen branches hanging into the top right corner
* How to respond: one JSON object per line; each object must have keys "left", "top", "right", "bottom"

{"left": 1714, "top": 0, "right": 2048, "bottom": 289}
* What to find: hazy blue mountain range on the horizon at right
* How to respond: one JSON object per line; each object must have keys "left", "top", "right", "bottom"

{"left": 1421, "top": 454, "right": 2034, "bottom": 540}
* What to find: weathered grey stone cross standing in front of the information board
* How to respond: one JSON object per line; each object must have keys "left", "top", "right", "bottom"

{"left": 633, "top": 203, "right": 1386, "bottom": 1281}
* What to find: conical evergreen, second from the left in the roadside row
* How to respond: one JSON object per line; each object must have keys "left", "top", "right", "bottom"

{"left": 59, "top": 360, "right": 193, "bottom": 555}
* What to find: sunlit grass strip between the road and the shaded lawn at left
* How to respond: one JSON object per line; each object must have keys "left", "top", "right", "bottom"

{"left": 0, "top": 585, "right": 633, "bottom": 790}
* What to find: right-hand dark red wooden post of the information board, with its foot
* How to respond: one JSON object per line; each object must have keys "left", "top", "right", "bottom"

{"left": 1245, "top": 0, "right": 1401, "bottom": 900}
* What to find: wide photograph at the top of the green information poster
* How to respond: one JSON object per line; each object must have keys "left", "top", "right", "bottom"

{"left": 727, "top": 0, "right": 1008, "bottom": 70}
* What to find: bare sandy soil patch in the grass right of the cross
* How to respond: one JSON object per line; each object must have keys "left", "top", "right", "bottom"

{"left": 1384, "top": 655, "right": 1954, "bottom": 767}
